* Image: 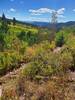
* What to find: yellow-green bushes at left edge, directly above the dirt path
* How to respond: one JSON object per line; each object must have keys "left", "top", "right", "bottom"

{"left": 0, "top": 52, "right": 22, "bottom": 75}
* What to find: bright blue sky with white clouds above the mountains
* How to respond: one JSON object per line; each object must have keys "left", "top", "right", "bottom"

{"left": 0, "top": 0, "right": 75, "bottom": 22}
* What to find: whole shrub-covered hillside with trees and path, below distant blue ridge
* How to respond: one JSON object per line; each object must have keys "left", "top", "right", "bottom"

{"left": 0, "top": 14, "right": 75, "bottom": 100}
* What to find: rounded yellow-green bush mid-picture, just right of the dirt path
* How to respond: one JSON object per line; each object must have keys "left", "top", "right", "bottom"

{"left": 23, "top": 51, "right": 58, "bottom": 79}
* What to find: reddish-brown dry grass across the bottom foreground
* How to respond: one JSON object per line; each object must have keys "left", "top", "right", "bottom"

{"left": 2, "top": 72, "right": 75, "bottom": 100}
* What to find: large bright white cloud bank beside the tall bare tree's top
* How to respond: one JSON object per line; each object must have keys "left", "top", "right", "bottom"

{"left": 28, "top": 8, "right": 65, "bottom": 22}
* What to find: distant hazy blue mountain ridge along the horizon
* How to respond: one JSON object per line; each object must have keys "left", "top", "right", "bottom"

{"left": 0, "top": 17, "right": 75, "bottom": 29}
